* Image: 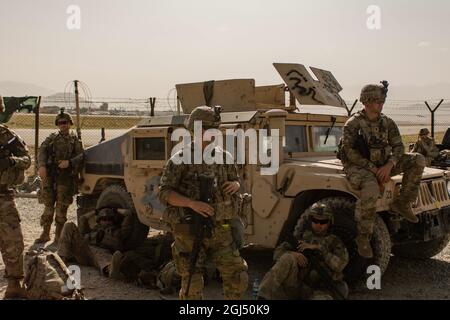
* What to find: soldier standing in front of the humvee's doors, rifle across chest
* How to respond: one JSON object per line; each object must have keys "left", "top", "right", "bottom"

{"left": 159, "top": 106, "right": 248, "bottom": 299}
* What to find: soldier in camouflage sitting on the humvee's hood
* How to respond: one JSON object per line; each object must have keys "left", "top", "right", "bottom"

{"left": 339, "top": 82, "right": 425, "bottom": 258}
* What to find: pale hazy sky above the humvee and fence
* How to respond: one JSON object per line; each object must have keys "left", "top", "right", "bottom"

{"left": 0, "top": 0, "right": 450, "bottom": 97}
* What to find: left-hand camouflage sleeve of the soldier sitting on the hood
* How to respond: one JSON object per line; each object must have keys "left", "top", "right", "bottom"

{"left": 342, "top": 117, "right": 376, "bottom": 169}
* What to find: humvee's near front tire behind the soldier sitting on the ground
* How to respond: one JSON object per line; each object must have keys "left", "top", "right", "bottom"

{"left": 298, "top": 197, "right": 391, "bottom": 283}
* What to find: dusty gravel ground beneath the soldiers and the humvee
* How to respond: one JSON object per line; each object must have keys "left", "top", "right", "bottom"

{"left": 0, "top": 199, "right": 450, "bottom": 299}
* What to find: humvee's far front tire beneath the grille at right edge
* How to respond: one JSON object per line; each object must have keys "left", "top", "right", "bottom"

{"left": 392, "top": 234, "right": 450, "bottom": 259}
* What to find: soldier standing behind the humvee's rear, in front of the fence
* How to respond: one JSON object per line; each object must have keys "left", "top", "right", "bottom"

{"left": 36, "top": 109, "right": 83, "bottom": 243}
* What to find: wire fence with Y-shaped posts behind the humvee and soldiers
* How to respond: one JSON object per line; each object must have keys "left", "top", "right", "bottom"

{"left": 8, "top": 95, "right": 450, "bottom": 147}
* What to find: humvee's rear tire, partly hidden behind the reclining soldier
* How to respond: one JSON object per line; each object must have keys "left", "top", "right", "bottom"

{"left": 96, "top": 184, "right": 149, "bottom": 250}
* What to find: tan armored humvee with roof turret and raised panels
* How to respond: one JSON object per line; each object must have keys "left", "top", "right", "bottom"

{"left": 77, "top": 64, "right": 450, "bottom": 281}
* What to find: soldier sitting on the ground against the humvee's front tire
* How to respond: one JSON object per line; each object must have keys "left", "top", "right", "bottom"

{"left": 258, "top": 204, "right": 349, "bottom": 300}
